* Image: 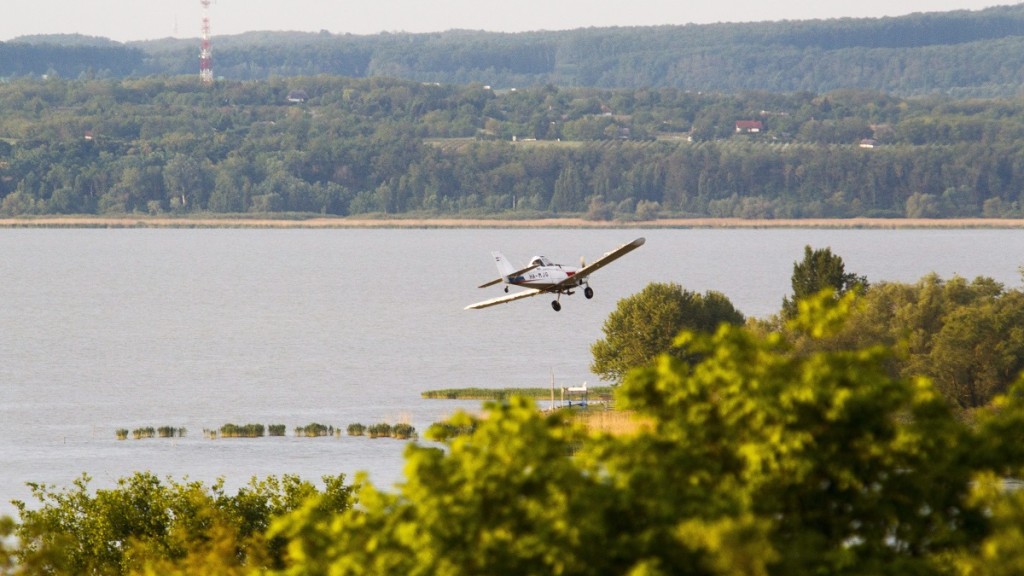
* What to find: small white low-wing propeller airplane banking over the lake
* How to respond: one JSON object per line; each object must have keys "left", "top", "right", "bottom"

{"left": 466, "top": 238, "right": 645, "bottom": 312}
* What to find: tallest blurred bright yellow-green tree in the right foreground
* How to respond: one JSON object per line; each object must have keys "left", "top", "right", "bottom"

{"left": 600, "top": 296, "right": 1007, "bottom": 574}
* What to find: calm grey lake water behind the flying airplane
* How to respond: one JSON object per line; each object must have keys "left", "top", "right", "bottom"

{"left": 0, "top": 229, "right": 1024, "bottom": 513}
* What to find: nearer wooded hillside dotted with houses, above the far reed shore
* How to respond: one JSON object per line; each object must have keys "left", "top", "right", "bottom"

{"left": 0, "top": 76, "right": 1024, "bottom": 220}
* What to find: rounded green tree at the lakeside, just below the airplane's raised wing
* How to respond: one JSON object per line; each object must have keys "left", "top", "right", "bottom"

{"left": 591, "top": 282, "right": 743, "bottom": 383}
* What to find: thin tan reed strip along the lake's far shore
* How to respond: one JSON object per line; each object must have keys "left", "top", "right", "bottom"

{"left": 0, "top": 214, "right": 1024, "bottom": 230}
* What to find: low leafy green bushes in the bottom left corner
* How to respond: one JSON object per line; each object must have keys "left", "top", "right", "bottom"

{"left": 0, "top": 472, "right": 354, "bottom": 575}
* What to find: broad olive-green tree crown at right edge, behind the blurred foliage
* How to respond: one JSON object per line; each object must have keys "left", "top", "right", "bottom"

{"left": 783, "top": 274, "right": 1024, "bottom": 411}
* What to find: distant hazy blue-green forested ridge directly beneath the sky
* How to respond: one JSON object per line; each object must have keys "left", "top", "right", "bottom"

{"left": 0, "top": 4, "right": 1024, "bottom": 96}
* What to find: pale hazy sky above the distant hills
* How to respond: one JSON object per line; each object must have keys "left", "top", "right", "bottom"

{"left": 0, "top": 0, "right": 1014, "bottom": 41}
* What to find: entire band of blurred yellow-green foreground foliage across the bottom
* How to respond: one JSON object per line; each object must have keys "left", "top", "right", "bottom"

{"left": 6, "top": 293, "right": 1024, "bottom": 575}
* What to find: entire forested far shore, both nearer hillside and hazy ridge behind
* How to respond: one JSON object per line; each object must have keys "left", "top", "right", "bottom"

{"left": 6, "top": 5, "right": 1024, "bottom": 220}
